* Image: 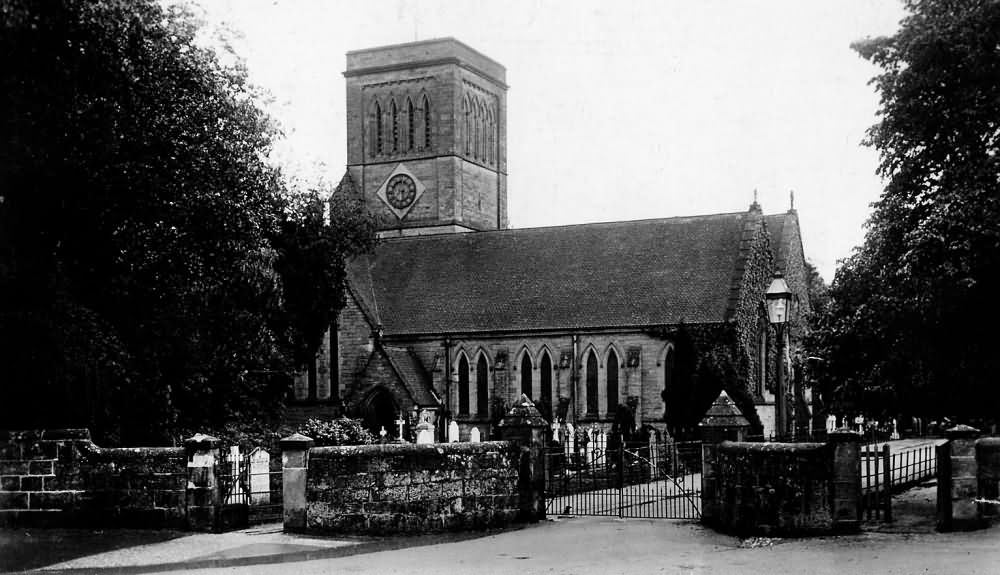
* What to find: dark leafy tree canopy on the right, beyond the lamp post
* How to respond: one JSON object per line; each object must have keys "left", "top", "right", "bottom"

{"left": 820, "top": 0, "right": 1000, "bottom": 419}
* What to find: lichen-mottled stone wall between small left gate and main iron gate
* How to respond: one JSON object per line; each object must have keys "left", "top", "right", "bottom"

{"left": 305, "top": 441, "right": 519, "bottom": 534}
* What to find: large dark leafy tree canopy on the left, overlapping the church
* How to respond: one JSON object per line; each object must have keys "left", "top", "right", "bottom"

{"left": 0, "top": 0, "right": 371, "bottom": 441}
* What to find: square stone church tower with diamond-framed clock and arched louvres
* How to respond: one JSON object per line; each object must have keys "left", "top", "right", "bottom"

{"left": 344, "top": 38, "right": 507, "bottom": 237}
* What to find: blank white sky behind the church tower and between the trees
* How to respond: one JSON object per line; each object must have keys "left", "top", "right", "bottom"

{"left": 193, "top": 0, "right": 903, "bottom": 281}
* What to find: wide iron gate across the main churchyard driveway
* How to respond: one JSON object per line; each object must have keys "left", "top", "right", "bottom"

{"left": 545, "top": 430, "right": 701, "bottom": 519}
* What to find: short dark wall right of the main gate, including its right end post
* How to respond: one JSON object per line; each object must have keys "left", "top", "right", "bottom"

{"left": 702, "top": 433, "right": 860, "bottom": 535}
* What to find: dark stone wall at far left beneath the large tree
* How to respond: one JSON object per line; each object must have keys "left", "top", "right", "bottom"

{"left": 0, "top": 429, "right": 188, "bottom": 528}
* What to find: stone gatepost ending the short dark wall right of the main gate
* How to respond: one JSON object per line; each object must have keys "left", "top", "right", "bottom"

{"left": 827, "top": 428, "right": 861, "bottom": 532}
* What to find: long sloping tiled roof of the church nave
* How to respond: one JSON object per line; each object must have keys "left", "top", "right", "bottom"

{"left": 349, "top": 212, "right": 759, "bottom": 336}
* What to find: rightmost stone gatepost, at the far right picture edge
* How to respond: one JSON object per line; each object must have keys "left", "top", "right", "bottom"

{"left": 938, "top": 425, "right": 983, "bottom": 531}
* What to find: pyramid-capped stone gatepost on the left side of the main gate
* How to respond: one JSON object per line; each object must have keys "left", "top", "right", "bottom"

{"left": 498, "top": 393, "right": 549, "bottom": 521}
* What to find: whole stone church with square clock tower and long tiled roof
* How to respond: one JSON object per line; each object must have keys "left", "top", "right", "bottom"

{"left": 287, "top": 38, "right": 809, "bottom": 441}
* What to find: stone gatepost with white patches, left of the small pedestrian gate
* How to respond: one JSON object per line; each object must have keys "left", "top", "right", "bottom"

{"left": 184, "top": 433, "right": 222, "bottom": 531}
